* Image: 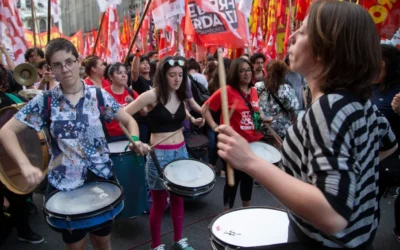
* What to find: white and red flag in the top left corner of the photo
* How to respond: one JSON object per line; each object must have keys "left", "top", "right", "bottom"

{"left": 0, "top": 0, "right": 28, "bottom": 64}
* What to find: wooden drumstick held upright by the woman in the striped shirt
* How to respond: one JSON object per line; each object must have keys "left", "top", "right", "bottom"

{"left": 218, "top": 49, "right": 235, "bottom": 187}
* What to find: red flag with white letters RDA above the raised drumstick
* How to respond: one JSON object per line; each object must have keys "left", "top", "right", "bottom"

{"left": 185, "top": 0, "right": 249, "bottom": 48}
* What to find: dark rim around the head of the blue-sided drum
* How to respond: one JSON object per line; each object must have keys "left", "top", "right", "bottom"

{"left": 43, "top": 180, "right": 124, "bottom": 220}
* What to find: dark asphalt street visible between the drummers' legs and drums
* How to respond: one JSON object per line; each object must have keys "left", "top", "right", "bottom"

{"left": 0, "top": 177, "right": 400, "bottom": 250}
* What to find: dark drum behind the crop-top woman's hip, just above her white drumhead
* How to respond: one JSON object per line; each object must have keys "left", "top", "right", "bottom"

{"left": 185, "top": 134, "right": 210, "bottom": 162}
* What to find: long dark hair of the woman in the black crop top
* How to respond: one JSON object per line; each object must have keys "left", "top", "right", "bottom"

{"left": 154, "top": 56, "right": 188, "bottom": 105}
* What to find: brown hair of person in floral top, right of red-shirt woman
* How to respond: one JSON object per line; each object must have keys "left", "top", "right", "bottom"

{"left": 264, "top": 60, "right": 288, "bottom": 94}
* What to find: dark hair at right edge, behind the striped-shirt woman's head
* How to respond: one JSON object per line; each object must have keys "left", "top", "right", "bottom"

{"left": 380, "top": 44, "right": 400, "bottom": 91}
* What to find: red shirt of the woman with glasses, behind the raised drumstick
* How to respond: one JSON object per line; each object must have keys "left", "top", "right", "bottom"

{"left": 206, "top": 86, "right": 263, "bottom": 142}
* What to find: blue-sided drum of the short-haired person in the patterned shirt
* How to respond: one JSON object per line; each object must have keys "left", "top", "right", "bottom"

{"left": 43, "top": 180, "right": 124, "bottom": 232}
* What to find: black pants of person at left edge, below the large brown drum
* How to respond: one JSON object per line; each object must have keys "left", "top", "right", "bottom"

{"left": 0, "top": 182, "right": 31, "bottom": 242}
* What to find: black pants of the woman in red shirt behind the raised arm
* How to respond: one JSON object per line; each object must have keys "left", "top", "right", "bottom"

{"left": 223, "top": 161, "right": 253, "bottom": 208}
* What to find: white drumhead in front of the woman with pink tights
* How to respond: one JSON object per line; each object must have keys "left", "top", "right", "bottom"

{"left": 164, "top": 159, "right": 215, "bottom": 188}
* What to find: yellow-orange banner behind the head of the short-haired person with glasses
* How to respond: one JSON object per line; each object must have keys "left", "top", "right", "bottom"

{"left": 25, "top": 26, "right": 84, "bottom": 55}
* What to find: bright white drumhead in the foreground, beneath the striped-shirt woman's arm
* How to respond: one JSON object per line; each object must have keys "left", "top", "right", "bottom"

{"left": 210, "top": 207, "right": 289, "bottom": 248}
